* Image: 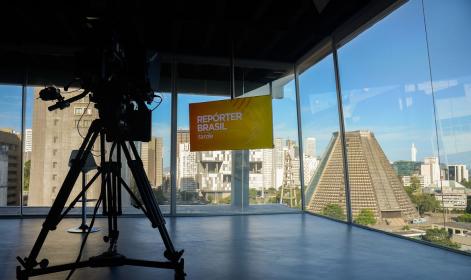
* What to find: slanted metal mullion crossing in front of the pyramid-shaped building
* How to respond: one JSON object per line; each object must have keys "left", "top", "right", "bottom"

{"left": 331, "top": 38, "right": 352, "bottom": 223}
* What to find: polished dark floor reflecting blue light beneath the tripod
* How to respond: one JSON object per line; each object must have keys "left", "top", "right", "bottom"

{"left": 0, "top": 214, "right": 471, "bottom": 280}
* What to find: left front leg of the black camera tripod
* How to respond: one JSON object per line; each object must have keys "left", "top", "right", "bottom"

{"left": 17, "top": 120, "right": 101, "bottom": 279}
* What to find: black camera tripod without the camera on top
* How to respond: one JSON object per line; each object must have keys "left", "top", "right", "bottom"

{"left": 16, "top": 119, "right": 185, "bottom": 280}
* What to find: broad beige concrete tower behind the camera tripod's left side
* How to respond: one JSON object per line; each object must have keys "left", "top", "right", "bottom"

{"left": 28, "top": 88, "right": 100, "bottom": 206}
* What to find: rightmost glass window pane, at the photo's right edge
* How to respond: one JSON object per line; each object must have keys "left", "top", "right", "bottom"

{"left": 423, "top": 0, "right": 471, "bottom": 252}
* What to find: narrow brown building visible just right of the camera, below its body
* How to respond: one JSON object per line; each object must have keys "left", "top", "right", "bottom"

{"left": 141, "top": 137, "right": 164, "bottom": 188}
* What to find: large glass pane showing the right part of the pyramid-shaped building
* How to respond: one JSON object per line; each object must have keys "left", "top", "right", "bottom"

{"left": 338, "top": 1, "right": 466, "bottom": 248}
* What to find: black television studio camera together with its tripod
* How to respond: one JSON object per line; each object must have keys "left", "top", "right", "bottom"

{"left": 17, "top": 20, "right": 186, "bottom": 280}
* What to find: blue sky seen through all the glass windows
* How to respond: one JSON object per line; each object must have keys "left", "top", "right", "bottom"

{"left": 0, "top": 0, "right": 471, "bottom": 166}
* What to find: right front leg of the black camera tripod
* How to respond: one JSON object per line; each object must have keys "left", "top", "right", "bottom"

{"left": 121, "top": 141, "right": 183, "bottom": 262}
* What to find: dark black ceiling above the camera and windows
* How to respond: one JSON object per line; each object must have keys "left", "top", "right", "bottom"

{"left": 0, "top": 0, "right": 396, "bottom": 89}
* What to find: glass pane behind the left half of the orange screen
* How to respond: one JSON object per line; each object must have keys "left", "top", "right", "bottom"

{"left": 175, "top": 63, "right": 233, "bottom": 213}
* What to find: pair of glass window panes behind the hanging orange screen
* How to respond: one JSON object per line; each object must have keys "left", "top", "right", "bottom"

{"left": 177, "top": 64, "right": 301, "bottom": 213}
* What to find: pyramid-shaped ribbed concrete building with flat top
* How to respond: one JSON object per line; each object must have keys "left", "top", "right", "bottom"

{"left": 306, "top": 131, "right": 418, "bottom": 221}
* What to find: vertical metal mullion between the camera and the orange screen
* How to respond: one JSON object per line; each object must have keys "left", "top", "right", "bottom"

{"left": 170, "top": 60, "right": 178, "bottom": 216}
